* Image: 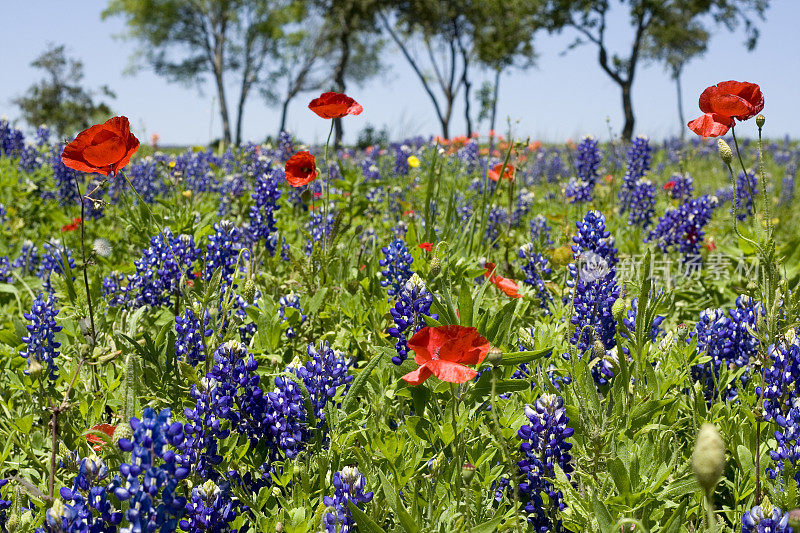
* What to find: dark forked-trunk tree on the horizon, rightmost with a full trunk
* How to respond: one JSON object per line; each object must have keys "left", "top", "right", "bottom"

{"left": 541, "top": 0, "right": 769, "bottom": 141}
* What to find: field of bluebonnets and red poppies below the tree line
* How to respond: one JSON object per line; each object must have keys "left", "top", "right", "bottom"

{"left": 0, "top": 82, "right": 800, "bottom": 533}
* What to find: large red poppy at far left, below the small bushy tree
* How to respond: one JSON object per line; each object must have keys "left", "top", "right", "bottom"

{"left": 61, "top": 117, "right": 139, "bottom": 176}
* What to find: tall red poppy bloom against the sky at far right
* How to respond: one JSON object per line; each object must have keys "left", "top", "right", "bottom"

{"left": 688, "top": 80, "right": 764, "bottom": 137}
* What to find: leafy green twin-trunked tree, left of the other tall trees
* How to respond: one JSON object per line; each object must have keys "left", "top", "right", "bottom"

{"left": 103, "top": 0, "right": 303, "bottom": 144}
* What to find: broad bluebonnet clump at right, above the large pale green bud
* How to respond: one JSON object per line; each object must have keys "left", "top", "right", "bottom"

{"left": 691, "top": 295, "right": 764, "bottom": 399}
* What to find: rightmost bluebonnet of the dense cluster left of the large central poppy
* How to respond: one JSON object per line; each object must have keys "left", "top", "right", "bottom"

{"left": 287, "top": 341, "right": 353, "bottom": 422}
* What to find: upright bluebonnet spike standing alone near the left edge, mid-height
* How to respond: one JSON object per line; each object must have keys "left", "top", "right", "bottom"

{"left": 20, "top": 294, "right": 61, "bottom": 381}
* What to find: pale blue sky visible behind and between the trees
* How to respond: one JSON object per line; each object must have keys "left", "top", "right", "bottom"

{"left": 0, "top": 0, "right": 800, "bottom": 144}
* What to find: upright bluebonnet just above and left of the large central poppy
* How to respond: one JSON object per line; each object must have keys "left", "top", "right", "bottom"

{"left": 387, "top": 274, "right": 439, "bottom": 365}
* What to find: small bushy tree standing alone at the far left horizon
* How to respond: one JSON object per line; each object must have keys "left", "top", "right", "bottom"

{"left": 14, "top": 44, "right": 114, "bottom": 138}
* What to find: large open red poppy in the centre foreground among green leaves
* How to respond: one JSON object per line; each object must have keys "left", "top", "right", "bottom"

{"left": 403, "top": 325, "right": 490, "bottom": 385}
